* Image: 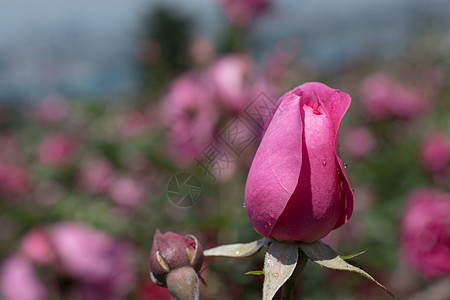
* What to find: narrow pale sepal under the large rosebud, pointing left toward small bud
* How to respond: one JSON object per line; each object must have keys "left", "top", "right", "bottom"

{"left": 203, "top": 238, "right": 271, "bottom": 257}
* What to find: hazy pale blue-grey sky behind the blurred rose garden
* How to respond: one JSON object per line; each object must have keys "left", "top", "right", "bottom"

{"left": 0, "top": 0, "right": 450, "bottom": 100}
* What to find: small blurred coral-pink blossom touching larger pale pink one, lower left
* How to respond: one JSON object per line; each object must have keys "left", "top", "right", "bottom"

{"left": 20, "top": 229, "right": 55, "bottom": 265}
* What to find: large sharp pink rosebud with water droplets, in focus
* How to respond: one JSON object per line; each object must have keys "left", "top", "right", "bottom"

{"left": 245, "top": 83, "right": 353, "bottom": 242}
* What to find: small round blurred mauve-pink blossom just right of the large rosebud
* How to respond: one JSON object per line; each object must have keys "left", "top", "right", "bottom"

{"left": 344, "top": 127, "right": 376, "bottom": 157}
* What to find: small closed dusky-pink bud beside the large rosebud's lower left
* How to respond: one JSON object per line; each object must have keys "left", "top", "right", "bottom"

{"left": 150, "top": 229, "right": 203, "bottom": 286}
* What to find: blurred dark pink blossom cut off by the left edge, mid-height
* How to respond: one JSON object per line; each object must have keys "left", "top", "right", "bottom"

{"left": 0, "top": 163, "right": 31, "bottom": 196}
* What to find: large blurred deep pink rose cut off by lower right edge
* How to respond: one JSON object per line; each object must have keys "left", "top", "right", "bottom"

{"left": 400, "top": 189, "right": 450, "bottom": 277}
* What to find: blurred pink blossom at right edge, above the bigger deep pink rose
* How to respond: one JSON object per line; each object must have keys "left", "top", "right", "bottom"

{"left": 420, "top": 132, "right": 450, "bottom": 175}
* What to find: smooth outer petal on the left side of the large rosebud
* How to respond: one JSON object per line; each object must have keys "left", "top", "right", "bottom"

{"left": 245, "top": 93, "right": 303, "bottom": 237}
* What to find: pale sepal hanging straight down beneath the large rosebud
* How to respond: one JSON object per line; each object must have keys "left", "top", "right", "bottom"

{"left": 263, "top": 241, "right": 298, "bottom": 300}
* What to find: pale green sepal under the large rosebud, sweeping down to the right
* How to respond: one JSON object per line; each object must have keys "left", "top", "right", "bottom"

{"left": 299, "top": 241, "right": 395, "bottom": 298}
